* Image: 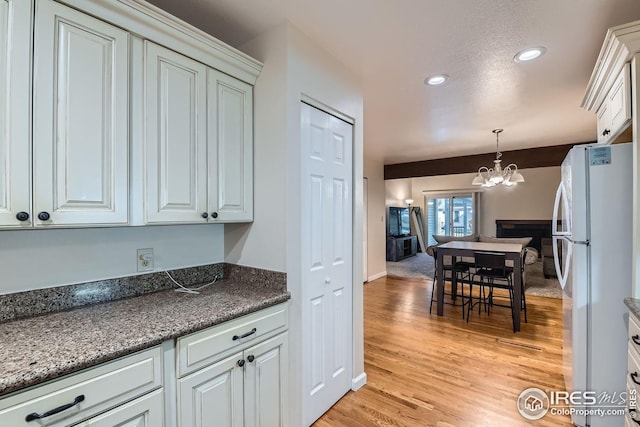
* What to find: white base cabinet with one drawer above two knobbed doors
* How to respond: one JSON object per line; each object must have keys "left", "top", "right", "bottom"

{"left": 177, "top": 304, "right": 289, "bottom": 427}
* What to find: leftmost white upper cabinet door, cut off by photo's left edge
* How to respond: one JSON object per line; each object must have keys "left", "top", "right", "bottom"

{"left": 0, "top": 0, "right": 32, "bottom": 227}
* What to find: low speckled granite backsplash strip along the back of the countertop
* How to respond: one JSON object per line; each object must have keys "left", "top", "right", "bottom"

{"left": 0, "top": 263, "right": 287, "bottom": 322}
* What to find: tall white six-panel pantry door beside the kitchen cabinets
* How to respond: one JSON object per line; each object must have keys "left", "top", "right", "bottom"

{"left": 301, "top": 103, "right": 353, "bottom": 425}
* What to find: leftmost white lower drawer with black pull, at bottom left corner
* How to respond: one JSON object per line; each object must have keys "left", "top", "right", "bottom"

{"left": 0, "top": 347, "right": 162, "bottom": 427}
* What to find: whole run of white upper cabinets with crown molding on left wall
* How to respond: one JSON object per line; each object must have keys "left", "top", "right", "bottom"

{"left": 0, "top": 0, "right": 262, "bottom": 229}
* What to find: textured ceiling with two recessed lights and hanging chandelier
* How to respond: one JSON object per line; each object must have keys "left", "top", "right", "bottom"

{"left": 146, "top": 0, "right": 640, "bottom": 164}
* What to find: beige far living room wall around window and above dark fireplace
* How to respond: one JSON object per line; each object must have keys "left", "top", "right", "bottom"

{"left": 404, "top": 166, "right": 560, "bottom": 236}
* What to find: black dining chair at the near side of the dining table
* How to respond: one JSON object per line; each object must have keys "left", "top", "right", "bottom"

{"left": 467, "top": 252, "right": 522, "bottom": 332}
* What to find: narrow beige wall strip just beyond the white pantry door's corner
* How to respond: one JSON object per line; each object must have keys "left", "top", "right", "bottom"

{"left": 364, "top": 157, "right": 387, "bottom": 280}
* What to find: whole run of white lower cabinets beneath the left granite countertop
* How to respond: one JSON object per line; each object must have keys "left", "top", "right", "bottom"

{"left": 0, "top": 304, "right": 289, "bottom": 427}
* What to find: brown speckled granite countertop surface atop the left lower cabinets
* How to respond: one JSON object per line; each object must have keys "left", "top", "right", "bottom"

{"left": 0, "top": 279, "right": 290, "bottom": 395}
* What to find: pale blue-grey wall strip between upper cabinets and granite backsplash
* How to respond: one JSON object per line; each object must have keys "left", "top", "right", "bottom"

{"left": 0, "top": 224, "right": 224, "bottom": 294}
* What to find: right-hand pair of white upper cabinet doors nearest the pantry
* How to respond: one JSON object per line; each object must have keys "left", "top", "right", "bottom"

{"left": 143, "top": 41, "right": 253, "bottom": 224}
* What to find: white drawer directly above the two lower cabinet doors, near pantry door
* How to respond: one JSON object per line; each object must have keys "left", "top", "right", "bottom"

{"left": 177, "top": 304, "right": 288, "bottom": 377}
